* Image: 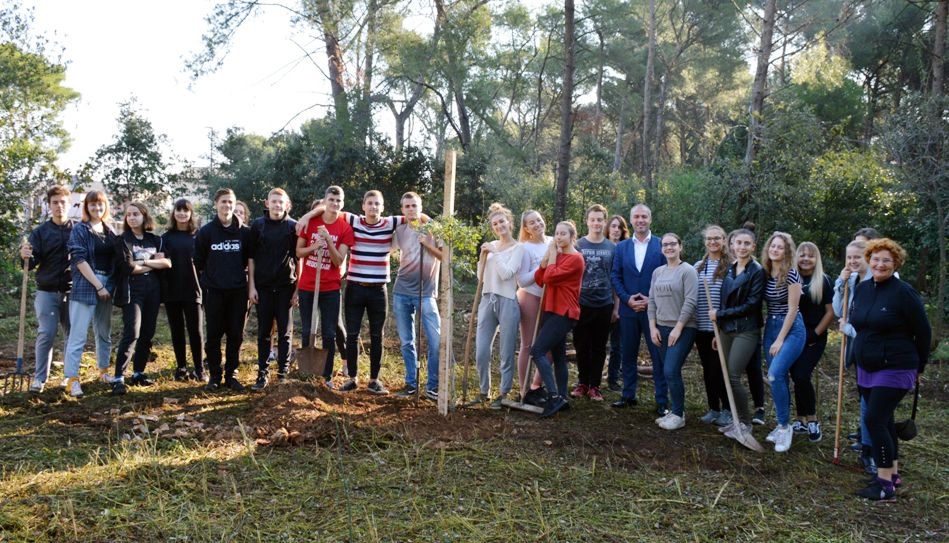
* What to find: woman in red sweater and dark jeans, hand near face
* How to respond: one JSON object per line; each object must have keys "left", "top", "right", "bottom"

{"left": 531, "top": 221, "right": 583, "bottom": 417}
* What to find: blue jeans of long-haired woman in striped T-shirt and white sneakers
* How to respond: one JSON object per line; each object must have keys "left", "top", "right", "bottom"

{"left": 761, "top": 313, "right": 807, "bottom": 426}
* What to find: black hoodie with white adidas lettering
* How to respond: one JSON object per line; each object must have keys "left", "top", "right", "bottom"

{"left": 194, "top": 216, "right": 250, "bottom": 290}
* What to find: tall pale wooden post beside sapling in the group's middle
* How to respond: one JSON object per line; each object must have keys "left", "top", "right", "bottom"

{"left": 438, "top": 149, "right": 456, "bottom": 415}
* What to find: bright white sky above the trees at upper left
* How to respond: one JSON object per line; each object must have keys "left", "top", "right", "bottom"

{"left": 23, "top": 0, "right": 340, "bottom": 171}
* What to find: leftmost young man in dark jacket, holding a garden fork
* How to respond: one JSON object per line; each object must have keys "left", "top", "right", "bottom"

{"left": 20, "top": 185, "right": 72, "bottom": 394}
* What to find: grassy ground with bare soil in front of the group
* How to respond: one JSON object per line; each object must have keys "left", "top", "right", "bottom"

{"left": 0, "top": 300, "right": 949, "bottom": 542}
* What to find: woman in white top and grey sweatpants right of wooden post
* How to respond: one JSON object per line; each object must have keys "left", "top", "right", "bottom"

{"left": 472, "top": 203, "right": 524, "bottom": 409}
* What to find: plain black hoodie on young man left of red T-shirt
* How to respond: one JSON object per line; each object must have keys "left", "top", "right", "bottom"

{"left": 250, "top": 215, "right": 297, "bottom": 288}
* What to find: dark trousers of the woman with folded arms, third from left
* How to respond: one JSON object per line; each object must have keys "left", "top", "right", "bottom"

{"left": 115, "top": 277, "right": 161, "bottom": 377}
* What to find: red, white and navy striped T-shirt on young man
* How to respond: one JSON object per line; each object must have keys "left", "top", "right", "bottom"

{"left": 346, "top": 213, "right": 405, "bottom": 283}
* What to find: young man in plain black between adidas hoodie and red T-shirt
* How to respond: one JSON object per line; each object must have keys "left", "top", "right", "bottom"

{"left": 247, "top": 188, "right": 300, "bottom": 390}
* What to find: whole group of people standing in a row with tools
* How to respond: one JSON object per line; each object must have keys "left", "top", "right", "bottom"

{"left": 21, "top": 186, "right": 931, "bottom": 506}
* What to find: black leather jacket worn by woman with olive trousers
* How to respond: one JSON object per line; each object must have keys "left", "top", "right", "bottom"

{"left": 716, "top": 260, "right": 765, "bottom": 334}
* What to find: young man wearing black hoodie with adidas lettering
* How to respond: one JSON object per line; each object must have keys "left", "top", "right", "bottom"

{"left": 194, "top": 189, "right": 250, "bottom": 392}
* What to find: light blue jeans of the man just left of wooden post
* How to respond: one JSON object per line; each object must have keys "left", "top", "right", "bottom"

{"left": 392, "top": 294, "right": 441, "bottom": 392}
